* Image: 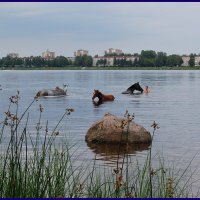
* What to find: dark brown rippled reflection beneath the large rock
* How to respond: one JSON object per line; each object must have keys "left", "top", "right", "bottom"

{"left": 87, "top": 142, "right": 150, "bottom": 162}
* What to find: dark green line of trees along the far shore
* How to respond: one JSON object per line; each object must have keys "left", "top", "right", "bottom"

{"left": 0, "top": 50, "right": 196, "bottom": 68}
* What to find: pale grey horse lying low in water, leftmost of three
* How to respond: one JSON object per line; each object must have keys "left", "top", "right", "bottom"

{"left": 36, "top": 85, "right": 67, "bottom": 97}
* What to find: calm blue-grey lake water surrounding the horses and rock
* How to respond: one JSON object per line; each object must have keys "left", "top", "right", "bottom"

{"left": 0, "top": 70, "right": 200, "bottom": 180}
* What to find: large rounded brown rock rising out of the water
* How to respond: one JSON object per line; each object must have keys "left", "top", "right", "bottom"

{"left": 85, "top": 113, "right": 152, "bottom": 143}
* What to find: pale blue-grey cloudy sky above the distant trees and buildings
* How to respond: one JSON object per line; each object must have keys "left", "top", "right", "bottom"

{"left": 0, "top": 2, "right": 200, "bottom": 57}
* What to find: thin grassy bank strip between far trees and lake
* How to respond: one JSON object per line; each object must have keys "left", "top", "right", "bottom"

{"left": 0, "top": 66, "right": 200, "bottom": 71}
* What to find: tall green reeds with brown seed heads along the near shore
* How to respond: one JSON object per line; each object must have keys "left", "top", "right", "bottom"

{"left": 0, "top": 93, "right": 199, "bottom": 198}
